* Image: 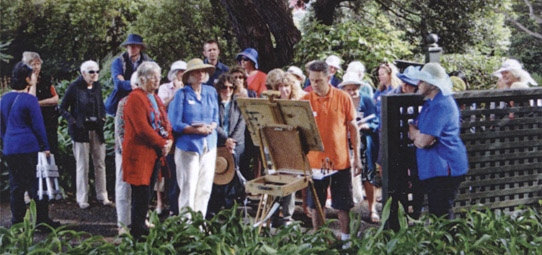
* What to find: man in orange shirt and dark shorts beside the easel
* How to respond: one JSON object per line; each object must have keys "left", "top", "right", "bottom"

{"left": 302, "top": 61, "right": 361, "bottom": 240}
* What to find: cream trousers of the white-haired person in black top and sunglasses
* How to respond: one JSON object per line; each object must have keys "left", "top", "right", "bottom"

{"left": 72, "top": 131, "right": 107, "bottom": 203}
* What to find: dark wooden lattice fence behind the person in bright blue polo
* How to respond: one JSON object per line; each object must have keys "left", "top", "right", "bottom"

{"left": 381, "top": 88, "right": 542, "bottom": 228}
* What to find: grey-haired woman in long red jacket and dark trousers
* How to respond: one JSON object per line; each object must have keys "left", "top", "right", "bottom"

{"left": 122, "top": 62, "right": 173, "bottom": 239}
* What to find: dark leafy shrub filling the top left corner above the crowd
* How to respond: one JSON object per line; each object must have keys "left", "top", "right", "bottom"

{"left": 0, "top": 0, "right": 148, "bottom": 79}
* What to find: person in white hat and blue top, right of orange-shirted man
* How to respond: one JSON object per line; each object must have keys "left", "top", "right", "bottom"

{"left": 339, "top": 72, "right": 380, "bottom": 223}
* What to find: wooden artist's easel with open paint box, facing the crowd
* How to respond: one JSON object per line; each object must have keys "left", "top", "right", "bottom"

{"left": 237, "top": 95, "right": 325, "bottom": 228}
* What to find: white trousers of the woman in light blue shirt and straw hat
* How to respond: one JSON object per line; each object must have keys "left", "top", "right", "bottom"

{"left": 175, "top": 148, "right": 216, "bottom": 217}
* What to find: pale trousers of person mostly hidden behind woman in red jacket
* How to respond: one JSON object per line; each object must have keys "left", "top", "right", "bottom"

{"left": 115, "top": 152, "right": 132, "bottom": 228}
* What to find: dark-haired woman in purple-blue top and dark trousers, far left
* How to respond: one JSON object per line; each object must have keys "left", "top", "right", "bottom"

{"left": 0, "top": 62, "right": 60, "bottom": 230}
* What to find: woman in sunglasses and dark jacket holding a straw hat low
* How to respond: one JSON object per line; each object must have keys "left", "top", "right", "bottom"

{"left": 207, "top": 74, "right": 246, "bottom": 218}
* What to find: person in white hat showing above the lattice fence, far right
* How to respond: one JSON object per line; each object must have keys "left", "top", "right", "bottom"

{"left": 493, "top": 59, "right": 538, "bottom": 88}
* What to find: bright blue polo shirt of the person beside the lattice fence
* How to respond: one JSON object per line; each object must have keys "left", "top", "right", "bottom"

{"left": 416, "top": 92, "right": 469, "bottom": 181}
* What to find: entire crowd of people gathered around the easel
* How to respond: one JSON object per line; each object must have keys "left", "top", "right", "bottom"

{"left": 0, "top": 34, "right": 536, "bottom": 240}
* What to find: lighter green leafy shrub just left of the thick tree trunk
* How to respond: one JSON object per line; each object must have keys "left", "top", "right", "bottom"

{"left": 131, "top": 0, "right": 239, "bottom": 74}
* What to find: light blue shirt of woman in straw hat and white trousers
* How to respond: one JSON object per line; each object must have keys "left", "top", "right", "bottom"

{"left": 168, "top": 84, "right": 218, "bottom": 155}
